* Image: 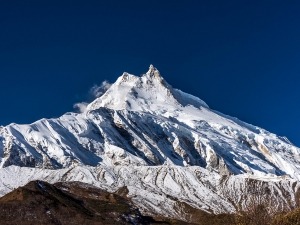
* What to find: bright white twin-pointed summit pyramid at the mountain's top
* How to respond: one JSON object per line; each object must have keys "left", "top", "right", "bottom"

{"left": 88, "top": 65, "right": 208, "bottom": 112}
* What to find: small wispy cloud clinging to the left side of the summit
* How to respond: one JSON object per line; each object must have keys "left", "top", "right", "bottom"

{"left": 73, "top": 80, "right": 111, "bottom": 113}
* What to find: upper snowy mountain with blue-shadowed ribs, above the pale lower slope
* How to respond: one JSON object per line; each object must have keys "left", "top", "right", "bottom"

{"left": 0, "top": 66, "right": 299, "bottom": 177}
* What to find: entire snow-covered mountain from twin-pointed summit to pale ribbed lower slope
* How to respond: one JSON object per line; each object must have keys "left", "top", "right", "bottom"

{"left": 0, "top": 66, "right": 300, "bottom": 220}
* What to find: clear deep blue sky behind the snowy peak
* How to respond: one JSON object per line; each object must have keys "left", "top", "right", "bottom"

{"left": 0, "top": 0, "right": 300, "bottom": 146}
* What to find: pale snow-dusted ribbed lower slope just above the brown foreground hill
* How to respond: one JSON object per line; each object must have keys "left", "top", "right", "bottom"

{"left": 0, "top": 165, "right": 300, "bottom": 217}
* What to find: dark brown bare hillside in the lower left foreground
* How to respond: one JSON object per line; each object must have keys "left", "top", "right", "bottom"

{"left": 0, "top": 181, "right": 193, "bottom": 225}
